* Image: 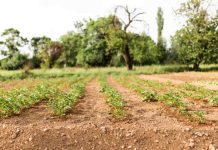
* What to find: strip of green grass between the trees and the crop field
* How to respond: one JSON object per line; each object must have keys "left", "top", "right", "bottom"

{"left": 0, "top": 65, "right": 218, "bottom": 81}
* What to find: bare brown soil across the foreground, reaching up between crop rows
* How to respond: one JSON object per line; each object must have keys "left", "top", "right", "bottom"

{"left": 0, "top": 77, "right": 218, "bottom": 150}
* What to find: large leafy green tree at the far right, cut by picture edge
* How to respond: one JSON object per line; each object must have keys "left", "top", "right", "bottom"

{"left": 172, "top": 0, "right": 218, "bottom": 70}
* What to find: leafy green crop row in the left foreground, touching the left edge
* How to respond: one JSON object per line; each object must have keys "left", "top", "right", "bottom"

{"left": 0, "top": 85, "right": 52, "bottom": 116}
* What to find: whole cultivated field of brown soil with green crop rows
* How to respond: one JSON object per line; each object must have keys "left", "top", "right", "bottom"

{"left": 0, "top": 68, "right": 218, "bottom": 150}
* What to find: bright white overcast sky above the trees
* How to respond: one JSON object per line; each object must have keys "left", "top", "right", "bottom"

{"left": 0, "top": 0, "right": 218, "bottom": 45}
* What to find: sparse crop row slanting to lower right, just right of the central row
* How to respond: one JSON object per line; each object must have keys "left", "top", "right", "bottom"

{"left": 114, "top": 76, "right": 205, "bottom": 123}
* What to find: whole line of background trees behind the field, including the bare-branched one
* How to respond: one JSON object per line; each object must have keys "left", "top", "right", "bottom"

{"left": 0, "top": 0, "right": 218, "bottom": 70}
